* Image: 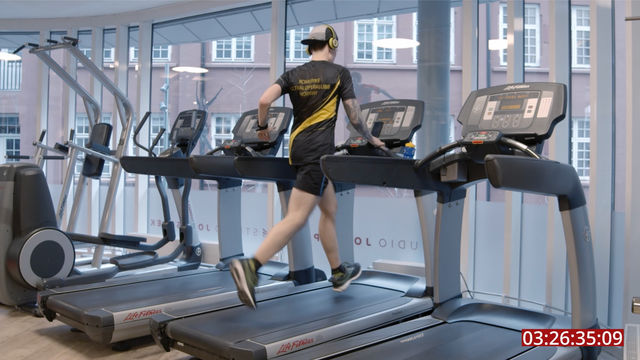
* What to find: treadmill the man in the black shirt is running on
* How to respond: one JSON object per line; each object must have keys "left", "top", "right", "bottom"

{"left": 151, "top": 100, "right": 433, "bottom": 359}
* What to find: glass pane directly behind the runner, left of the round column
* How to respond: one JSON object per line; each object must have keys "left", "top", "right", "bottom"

{"left": 285, "top": 1, "right": 462, "bottom": 271}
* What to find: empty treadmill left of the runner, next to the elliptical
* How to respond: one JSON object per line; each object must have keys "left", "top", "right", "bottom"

{"left": 38, "top": 108, "right": 300, "bottom": 344}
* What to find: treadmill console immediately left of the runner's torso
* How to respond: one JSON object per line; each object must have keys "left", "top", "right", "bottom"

{"left": 222, "top": 107, "right": 293, "bottom": 155}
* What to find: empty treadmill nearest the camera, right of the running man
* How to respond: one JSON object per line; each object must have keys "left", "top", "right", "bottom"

{"left": 289, "top": 83, "right": 600, "bottom": 359}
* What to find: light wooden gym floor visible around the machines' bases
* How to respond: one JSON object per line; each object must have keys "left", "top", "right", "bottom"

{"left": 0, "top": 305, "right": 623, "bottom": 360}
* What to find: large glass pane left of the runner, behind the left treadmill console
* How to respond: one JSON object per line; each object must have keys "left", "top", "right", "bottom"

{"left": 149, "top": 5, "right": 271, "bottom": 254}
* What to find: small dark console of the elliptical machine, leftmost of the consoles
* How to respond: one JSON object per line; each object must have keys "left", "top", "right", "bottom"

{"left": 169, "top": 110, "right": 207, "bottom": 154}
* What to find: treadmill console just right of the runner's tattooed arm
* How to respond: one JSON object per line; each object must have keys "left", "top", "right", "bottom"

{"left": 347, "top": 99, "right": 424, "bottom": 149}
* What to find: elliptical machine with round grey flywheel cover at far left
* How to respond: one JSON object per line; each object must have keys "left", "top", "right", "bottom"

{"left": 0, "top": 110, "right": 206, "bottom": 305}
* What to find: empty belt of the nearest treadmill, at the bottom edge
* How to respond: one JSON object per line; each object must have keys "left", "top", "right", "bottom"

{"left": 340, "top": 321, "right": 531, "bottom": 360}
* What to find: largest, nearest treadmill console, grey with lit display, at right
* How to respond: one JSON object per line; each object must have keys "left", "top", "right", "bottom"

{"left": 458, "top": 83, "right": 567, "bottom": 146}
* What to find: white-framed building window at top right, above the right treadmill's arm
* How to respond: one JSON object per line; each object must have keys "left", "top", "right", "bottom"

{"left": 571, "top": 6, "right": 591, "bottom": 68}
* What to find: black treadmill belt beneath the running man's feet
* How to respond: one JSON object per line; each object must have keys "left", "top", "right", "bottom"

{"left": 167, "top": 284, "right": 404, "bottom": 353}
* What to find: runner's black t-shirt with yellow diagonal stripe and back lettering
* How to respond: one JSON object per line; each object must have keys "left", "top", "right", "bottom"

{"left": 276, "top": 61, "right": 356, "bottom": 165}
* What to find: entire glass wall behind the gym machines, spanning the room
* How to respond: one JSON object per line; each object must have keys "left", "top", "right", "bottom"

{"left": 0, "top": 0, "right": 635, "bottom": 330}
